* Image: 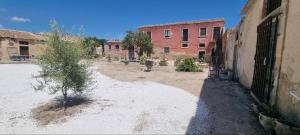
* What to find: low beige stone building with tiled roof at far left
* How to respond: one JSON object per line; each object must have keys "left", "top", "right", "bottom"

{"left": 0, "top": 29, "right": 45, "bottom": 62}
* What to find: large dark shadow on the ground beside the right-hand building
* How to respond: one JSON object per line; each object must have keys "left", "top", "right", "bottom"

{"left": 186, "top": 78, "right": 269, "bottom": 135}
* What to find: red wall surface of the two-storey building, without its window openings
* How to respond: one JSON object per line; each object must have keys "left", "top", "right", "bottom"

{"left": 139, "top": 21, "right": 224, "bottom": 57}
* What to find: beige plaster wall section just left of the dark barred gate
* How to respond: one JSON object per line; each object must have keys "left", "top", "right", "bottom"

{"left": 237, "top": 0, "right": 264, "bottom": 89}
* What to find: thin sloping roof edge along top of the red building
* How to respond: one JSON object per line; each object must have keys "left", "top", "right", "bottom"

{"left": 139, "top": 18, "right": 225, "bottom": 28}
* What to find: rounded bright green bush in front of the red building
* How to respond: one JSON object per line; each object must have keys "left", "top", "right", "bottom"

{"left": 176, "top": 58, "right": 200, "bottom": 72}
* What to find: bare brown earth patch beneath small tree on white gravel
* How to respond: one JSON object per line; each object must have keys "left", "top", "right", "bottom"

{"left": 32, "top": 95, "right": 93, "bottom": 126}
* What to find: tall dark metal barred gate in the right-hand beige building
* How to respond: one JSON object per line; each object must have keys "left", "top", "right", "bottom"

{"left": 251, "top": 16, "right": 279, "bottom": 106}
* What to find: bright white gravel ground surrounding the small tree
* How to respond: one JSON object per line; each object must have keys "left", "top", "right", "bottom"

{"left": 0, "top": 64, "right": 208, "bottom": 134}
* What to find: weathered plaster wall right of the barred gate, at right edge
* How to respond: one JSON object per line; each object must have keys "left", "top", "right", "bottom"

{"left": 277, "top": 0, "right": 300, "bottom": 125}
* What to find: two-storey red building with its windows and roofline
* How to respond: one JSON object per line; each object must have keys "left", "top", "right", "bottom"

{"left": 139, "top": 19, "right": 224, "bottom": 59}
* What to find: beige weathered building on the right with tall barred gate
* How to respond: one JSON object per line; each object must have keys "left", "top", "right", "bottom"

{"left": 226, "top": 0, "right": 300, "bottom": 126}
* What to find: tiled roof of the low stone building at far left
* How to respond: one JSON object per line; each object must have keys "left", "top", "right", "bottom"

{"left": 0, "top": 29, "right": 44, "bottom": 40}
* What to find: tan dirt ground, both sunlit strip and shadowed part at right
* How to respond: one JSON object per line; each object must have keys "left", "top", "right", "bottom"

{"left": 96, "top": 60, "right": 269, "bottom": 135}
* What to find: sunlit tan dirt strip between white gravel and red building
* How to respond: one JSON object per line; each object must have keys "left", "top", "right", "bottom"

{"left": 95, "top": 59, "right": 208, "bottom": 97}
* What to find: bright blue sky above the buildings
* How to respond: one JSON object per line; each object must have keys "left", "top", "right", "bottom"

{"left": 0, "top": 0, "right": 246, "bottom": 39}
